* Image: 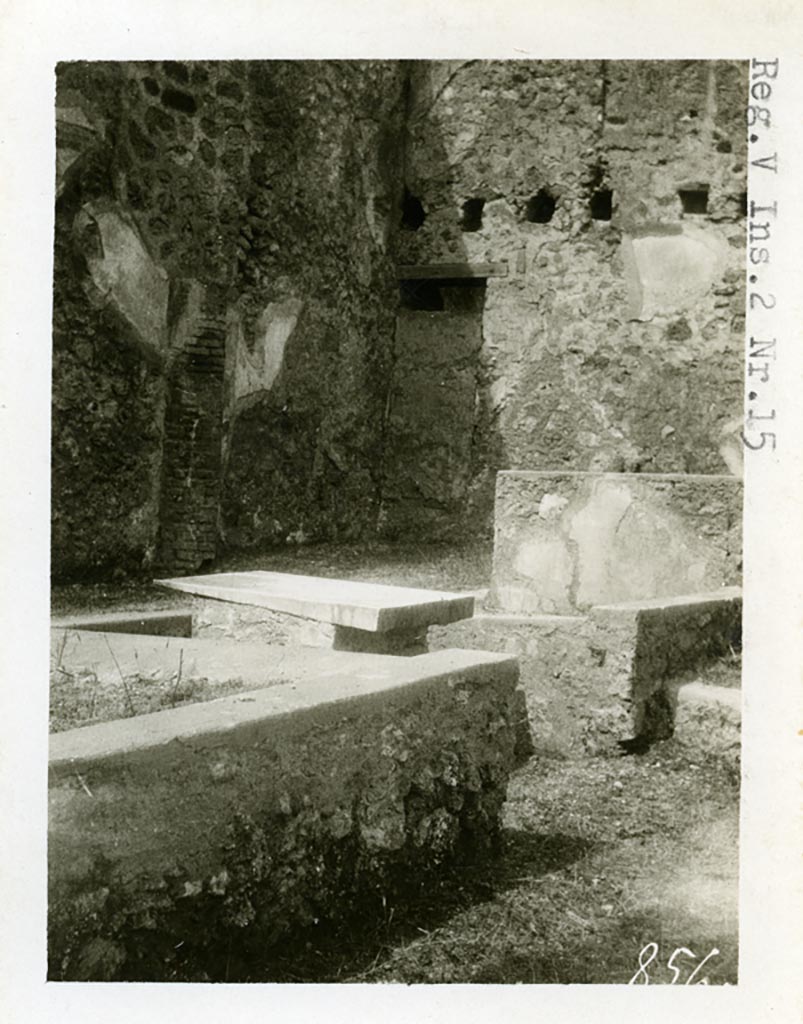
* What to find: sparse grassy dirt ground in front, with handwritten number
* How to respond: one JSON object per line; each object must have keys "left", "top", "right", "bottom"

{"left": 229, "top": 740, "right": 738, "bottom": 985}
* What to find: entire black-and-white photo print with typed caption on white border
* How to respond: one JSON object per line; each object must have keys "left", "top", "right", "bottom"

{"left": 3, "top": 5, "right": 803, "bottom": 1022}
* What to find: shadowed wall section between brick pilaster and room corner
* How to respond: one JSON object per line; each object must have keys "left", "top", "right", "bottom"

{"left": 222, "top": 61, "right": 404, "bottom": 547}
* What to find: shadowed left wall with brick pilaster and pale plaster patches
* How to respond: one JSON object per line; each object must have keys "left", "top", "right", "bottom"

{"left": 52, "top": 60, "right": 402, "bottom": 575}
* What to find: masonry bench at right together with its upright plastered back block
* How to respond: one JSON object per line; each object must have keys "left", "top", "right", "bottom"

{"left": 428, "top": 470, "right": 743, "bottom": 755}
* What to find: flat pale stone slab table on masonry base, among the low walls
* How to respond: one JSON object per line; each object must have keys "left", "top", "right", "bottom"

{"left": 155, "top": 571, "right": 474, "bottom": 655}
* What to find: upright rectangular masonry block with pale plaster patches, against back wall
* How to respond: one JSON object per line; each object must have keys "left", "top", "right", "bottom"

{"left": 490, "top": 470, "right": 742, "bottom": 614}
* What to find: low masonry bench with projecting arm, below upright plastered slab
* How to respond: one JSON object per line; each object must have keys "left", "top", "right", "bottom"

{"left": 429, "top": 587, "right": 742, "bottom": 756}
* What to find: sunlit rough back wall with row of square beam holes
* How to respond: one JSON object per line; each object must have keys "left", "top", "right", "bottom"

{"left": 397, "top": 60, "right": 747, "bottom": 536}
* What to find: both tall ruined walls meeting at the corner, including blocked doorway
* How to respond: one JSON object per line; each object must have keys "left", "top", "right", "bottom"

{"left": 52, "top": 60, "right": 746, "bottom": 579}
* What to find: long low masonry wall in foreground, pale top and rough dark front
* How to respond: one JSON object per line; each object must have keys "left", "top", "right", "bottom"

{"left": 48, "top": 651, "right": 518, "bottom": 981}
